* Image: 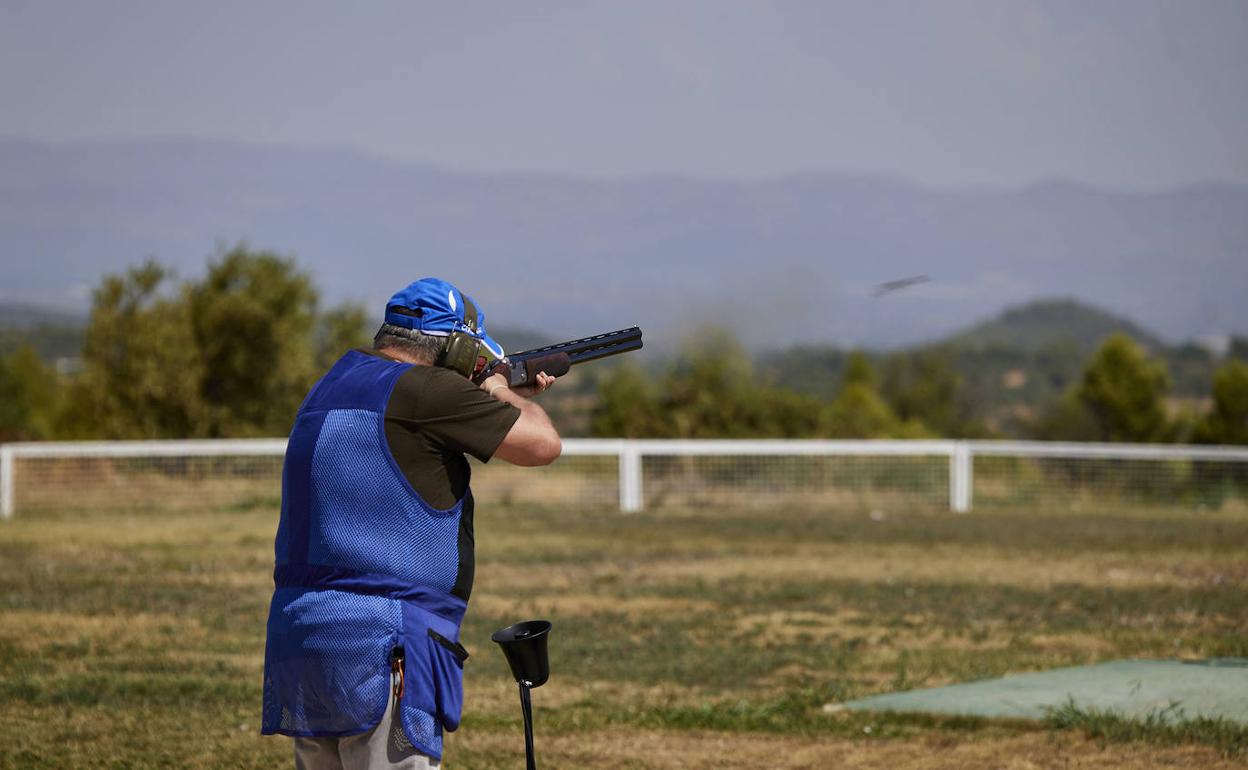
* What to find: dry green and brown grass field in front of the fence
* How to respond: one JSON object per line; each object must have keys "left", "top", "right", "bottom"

{"left": 0, "top": 499, "right": 1248, "bottom": 769}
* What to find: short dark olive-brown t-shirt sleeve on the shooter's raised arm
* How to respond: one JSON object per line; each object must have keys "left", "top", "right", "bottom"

{"left": 386, "top": 366, "right": 520, "bottom": 462}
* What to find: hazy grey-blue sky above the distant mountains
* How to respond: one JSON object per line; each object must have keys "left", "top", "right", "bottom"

{"left": 0, "top": 0, "right": 1248, "bottom": 190}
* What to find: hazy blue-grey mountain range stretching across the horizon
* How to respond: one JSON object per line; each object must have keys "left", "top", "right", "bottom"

{"left": 0, "top": 139, "right": 1248, "bottom": 349}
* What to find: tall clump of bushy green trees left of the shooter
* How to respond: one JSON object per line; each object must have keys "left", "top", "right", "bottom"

{"left": 59, "top": 246, "right": 324, "bottom": 438}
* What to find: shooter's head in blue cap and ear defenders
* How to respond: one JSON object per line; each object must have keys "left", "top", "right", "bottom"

{"left": 373, "top": 278, "right": 503, "bottom": 378}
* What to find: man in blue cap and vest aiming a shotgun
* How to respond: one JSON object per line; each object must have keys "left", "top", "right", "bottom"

{"left": 263, "top": 278, "right": 562, "bottom": 770}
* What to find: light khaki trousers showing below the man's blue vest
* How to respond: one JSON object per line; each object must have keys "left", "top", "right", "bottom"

{"left": 295, "top": 698, "right": 442, "bottom": 770}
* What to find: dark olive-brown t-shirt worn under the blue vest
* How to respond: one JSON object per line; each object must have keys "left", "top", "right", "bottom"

{"left": 359, "top": 349, "right": 520, "bottom": 600}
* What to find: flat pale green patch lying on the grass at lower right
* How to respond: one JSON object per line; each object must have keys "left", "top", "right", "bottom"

{"left": 842, "top": 658, "right": 1248, "bottom": 724}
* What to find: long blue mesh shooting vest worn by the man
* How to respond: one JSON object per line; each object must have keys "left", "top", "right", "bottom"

{"left": 262, "top": 352, "right": 470, "bottom": 758}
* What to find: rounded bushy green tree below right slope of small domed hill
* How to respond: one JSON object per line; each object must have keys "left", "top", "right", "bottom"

{"left": 1076, "top": 333, "right": 1169, "bottom": 442}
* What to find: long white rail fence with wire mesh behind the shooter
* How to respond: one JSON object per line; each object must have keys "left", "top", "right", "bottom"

{"left": 0, "top": 439, "right": 1248, "bottom": 518}
